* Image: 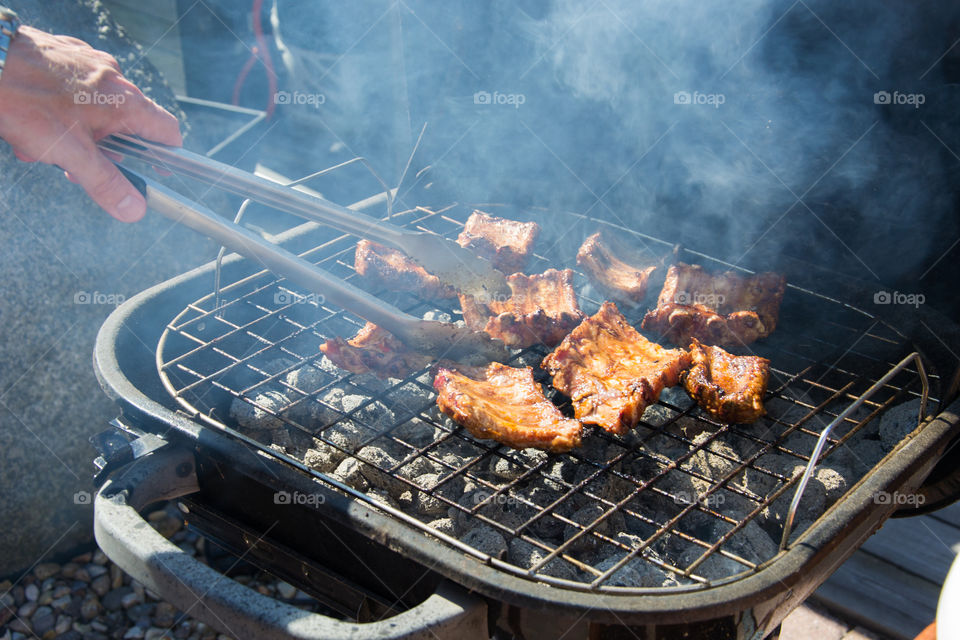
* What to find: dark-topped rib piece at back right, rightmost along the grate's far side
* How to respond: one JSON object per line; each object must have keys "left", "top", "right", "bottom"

{"left": 643, "top": 263, "right": 786, "bottom": 345}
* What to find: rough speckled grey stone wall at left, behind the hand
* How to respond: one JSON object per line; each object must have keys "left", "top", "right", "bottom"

{"left": 0, "top": 0, "right": 215, "bottom": 576}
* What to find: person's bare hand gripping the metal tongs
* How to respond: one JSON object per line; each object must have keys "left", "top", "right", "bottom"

{"left": 0, "top": 26, "right": 183, "bottom": 222}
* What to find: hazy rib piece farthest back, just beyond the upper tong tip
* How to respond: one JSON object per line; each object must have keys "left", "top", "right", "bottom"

{"left": 457, "top": 211, "right": 540, "bottom": 275}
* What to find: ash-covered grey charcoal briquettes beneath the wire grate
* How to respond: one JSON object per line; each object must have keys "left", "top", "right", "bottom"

{"left": 231, "top": 358, "right": 917, "bottom": 587}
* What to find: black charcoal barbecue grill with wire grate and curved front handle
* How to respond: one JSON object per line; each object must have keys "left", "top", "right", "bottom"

{"left": 95, "top": 156, "right": 960, "bottom": 638}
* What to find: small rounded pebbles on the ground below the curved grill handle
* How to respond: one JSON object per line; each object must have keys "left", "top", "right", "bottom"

{"left": 0, "top": 504, "right": 319, "bottom": 640}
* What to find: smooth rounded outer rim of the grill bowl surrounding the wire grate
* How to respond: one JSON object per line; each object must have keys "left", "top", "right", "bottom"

{"left": 94, "top": 211, "right": 960, "bottom": 624}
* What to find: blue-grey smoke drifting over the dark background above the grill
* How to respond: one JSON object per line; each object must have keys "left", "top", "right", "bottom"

{"left": 268, "top": 0, "right": 960, "bottom": 282}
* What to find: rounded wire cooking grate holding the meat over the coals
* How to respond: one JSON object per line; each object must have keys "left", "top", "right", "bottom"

{"left": 157, "top": 205, "right": 937, "bottom": 592}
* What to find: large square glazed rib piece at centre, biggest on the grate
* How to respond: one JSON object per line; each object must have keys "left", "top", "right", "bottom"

{"left": 540, "top": 302, "right": 690, "bottom": 434}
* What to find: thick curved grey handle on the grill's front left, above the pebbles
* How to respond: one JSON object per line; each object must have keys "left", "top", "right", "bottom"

{"left": 94, "top": 446, "right": 489, "bottom": 640}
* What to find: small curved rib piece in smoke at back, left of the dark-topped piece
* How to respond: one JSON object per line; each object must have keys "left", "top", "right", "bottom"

{"left": 577, "top": 232, "right": 657, "bottom": 305}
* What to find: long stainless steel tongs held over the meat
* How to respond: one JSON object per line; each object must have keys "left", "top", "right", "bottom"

{"left": 99, "top": 135, "right": 510, "bottom": 364}
